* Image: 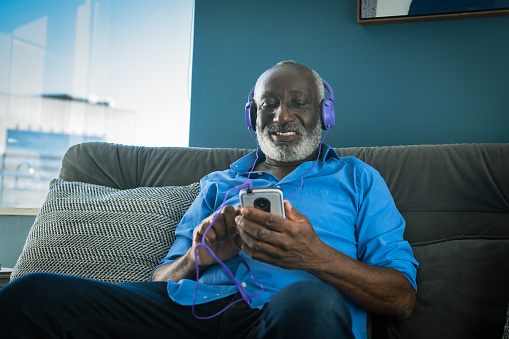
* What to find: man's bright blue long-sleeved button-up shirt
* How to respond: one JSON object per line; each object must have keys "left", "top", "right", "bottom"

{"left": 156, "top": 145, "right": 418, "bottom": 338}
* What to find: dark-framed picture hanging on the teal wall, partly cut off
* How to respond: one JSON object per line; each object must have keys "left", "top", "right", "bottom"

{"left": 357, "top": 0, "right": 509, "bottom": 26}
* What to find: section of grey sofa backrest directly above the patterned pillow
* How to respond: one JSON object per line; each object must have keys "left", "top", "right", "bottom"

{"left": 59, "top": 142, "right": 251, "bottom": 189}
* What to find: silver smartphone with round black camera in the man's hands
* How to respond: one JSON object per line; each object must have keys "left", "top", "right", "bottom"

{"left": 239, "top": 187, "right": 285, "bottom": 218}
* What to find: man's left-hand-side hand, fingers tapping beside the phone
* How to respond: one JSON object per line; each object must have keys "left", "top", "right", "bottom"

{"left": 192, "top": 205, "right": 244, "bottom": 268}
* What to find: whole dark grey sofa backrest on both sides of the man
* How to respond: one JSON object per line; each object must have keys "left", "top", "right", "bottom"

{"left": 60, "top": 143, "right": 509, "bottom": 243}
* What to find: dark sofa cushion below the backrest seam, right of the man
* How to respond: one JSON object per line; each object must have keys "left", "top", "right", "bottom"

{"left": 373, "top": 237, "right": 509, "bottom": 339}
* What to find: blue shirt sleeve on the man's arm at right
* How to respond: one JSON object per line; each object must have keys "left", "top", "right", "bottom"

{"left": 356, "top": 167, "right": 419, "bottom": 290}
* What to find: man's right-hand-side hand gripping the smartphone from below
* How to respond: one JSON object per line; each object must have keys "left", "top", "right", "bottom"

{"left": 235, "top": 200, "right": 326, "bottom": 270}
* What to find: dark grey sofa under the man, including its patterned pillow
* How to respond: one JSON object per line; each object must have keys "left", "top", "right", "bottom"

{"left": 8, "top": 143, "right": 509, "bottom": 339}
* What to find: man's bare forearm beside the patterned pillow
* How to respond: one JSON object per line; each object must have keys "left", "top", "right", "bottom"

{"left": 151, "top": 248, "right": 200, "bottom": 282}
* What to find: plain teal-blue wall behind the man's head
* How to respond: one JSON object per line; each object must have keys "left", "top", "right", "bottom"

{"left": 190, "top": 0, "right": 509, "bottom": 148}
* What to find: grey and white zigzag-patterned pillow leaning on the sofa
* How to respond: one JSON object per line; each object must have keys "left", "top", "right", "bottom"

{"left": 11, "top": 179, "right": 199, "bottom": 282}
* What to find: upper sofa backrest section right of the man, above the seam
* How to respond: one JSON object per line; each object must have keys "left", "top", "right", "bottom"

{"left": 338, "top": 144, "right": 509, "bottom": 243}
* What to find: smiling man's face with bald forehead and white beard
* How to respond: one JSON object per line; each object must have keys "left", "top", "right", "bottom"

{"left": 256, "top": 66, "right": 322, "bottom": 163}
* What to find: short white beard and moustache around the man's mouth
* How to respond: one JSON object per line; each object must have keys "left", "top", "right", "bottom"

{"left": 257, "top": 121, "right": 322, "bottom": 162}
